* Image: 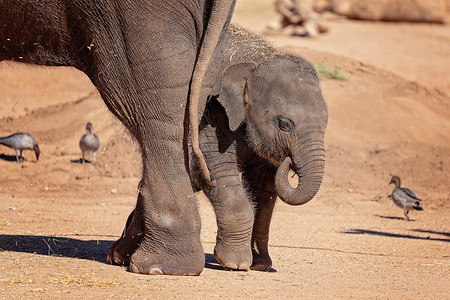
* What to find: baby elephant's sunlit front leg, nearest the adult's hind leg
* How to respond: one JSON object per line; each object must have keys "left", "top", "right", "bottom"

{"left": 197, "top": 122, "right": 253, "bottom": 270}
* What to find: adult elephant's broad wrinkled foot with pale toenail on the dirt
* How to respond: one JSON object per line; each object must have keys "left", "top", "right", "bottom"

{"left": 126, "top": 239, "right": 205, "bottom": 276}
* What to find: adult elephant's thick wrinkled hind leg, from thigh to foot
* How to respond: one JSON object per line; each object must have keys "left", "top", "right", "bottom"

{"left": 92, "top": 19, "right": 206, "bottom": 275}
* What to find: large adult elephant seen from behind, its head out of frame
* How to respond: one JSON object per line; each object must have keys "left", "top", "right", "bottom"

{"left": 0, "top": 0, "right": 235, "bottom": 275}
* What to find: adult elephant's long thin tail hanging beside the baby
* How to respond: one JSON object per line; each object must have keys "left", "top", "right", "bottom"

{"left": 189, "top": 0, "right": 235, "bottom": 186}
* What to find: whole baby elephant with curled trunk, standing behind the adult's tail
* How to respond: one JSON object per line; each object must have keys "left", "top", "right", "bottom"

{"left": 194, "top": 25, "right": 328, "bottom": 270}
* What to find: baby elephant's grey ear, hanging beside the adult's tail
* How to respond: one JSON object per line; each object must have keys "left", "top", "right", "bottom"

{"left": 212, "top": 62, "right": 256, "bottom": 131}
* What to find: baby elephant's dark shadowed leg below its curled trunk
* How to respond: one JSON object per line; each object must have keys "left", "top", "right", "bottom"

{"left": 243, "top": 162, "right": 277, "bottom": 271}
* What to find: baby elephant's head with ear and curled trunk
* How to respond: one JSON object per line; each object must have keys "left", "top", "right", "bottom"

{"left": 213, "top": 55, "right": 328, "bottom": 205}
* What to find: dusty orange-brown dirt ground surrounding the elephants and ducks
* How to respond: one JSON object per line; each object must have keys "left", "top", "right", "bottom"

{"left": 0, "top": 0, "right": 450, "bottom": 299}
